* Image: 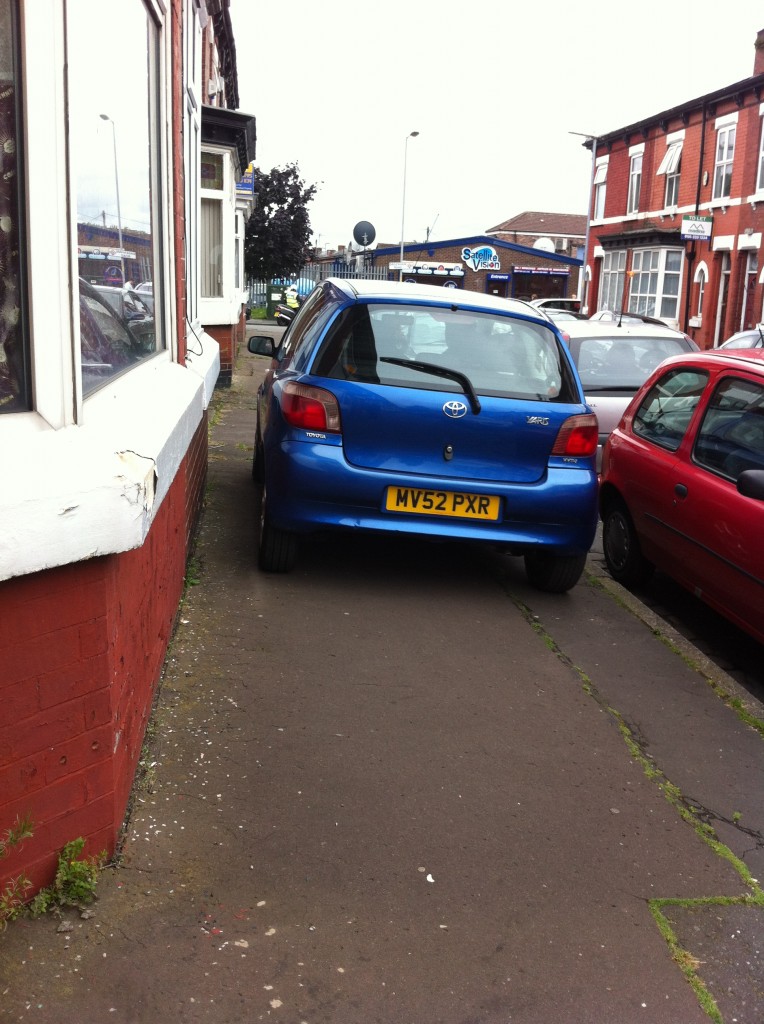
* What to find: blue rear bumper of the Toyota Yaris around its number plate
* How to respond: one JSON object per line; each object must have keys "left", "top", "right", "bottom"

{"left": 265, "top": 440, "right": 597, "bottom": 554}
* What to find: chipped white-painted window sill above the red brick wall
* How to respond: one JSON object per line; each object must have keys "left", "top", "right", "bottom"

{"left": 0, "top": 339, "right": 219, "bottom": 580}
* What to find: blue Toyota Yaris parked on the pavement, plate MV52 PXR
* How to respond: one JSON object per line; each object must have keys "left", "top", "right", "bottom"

{"left": 249, "top": 279, "right": 597, "bottom": 592}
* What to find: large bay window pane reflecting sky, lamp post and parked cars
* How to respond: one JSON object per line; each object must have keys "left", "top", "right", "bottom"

{"left": 69, "top": 0, "right": 164, "bottom": 394}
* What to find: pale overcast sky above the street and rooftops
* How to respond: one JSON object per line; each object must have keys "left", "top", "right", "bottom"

{"left": 230, "top": 0, "right": 764, "bottom": 248}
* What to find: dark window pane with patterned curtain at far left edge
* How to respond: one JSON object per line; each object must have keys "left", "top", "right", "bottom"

{"left": 0, "top": 0, "right": 31, "bottom": 413}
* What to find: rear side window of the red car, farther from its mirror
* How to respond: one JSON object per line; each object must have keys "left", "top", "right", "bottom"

{"left": 632, "top": 367, "right": 708, "bottom": 452}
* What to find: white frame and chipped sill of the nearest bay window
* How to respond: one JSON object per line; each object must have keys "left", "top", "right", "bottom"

{"left": 0, "top": 0, "right": 219, "bottom": 580}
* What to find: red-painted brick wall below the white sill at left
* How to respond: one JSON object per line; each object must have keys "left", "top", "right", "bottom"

{"left": 0, "top": 448, "right": 199, "bottom": 891}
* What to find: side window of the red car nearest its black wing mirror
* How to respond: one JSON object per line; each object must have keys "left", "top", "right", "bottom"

{"left": 692, "top": 377, "right": 764, "bottom": 480}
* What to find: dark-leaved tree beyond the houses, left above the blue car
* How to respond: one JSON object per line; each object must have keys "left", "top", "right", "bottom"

{"left": 244, "top": 164, "right": 317, "bottom": 281}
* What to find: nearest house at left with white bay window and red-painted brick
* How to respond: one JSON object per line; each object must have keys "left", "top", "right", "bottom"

{"left": 0, "top": 0, "right": 254, "bottom": 894}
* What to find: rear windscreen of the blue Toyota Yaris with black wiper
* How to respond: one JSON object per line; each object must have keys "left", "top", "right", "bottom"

{"left": 312, "top": 303, "right": 579, "bottom": 402}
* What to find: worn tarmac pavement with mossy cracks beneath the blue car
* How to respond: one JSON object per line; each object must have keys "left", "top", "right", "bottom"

{"left": 0, "top": 324, "right": 764, "bottom": 1024}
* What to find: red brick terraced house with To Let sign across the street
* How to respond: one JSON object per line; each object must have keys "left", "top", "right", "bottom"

{"left": 583, "top": 32, "right": 764, "bottom": 348}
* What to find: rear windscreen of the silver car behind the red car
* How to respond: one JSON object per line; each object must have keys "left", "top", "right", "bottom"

{"left": 570, "top": 333, "right": 687, "bottom": 391}
